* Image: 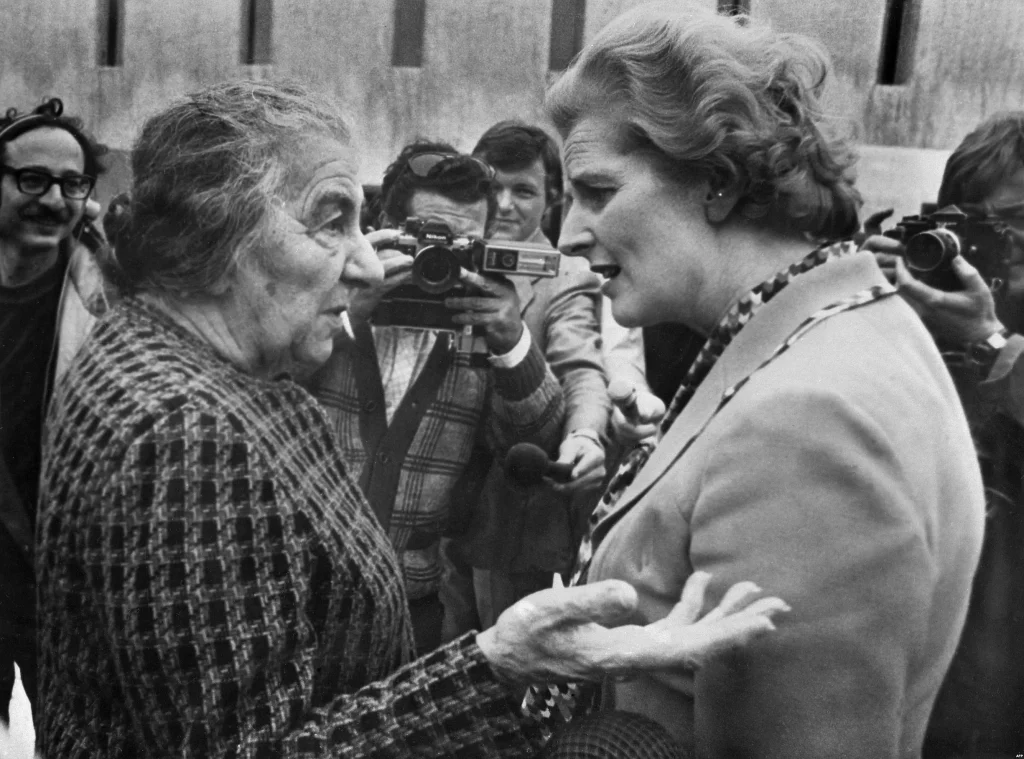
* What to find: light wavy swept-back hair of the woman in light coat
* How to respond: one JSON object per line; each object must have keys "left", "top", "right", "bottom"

{"left": 546, "top": 2, "right": 861, "bottom": 240}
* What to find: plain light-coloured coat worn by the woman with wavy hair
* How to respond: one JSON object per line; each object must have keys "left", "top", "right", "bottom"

{"left": 590, "top": 254, "right": 983, "bottom": 759}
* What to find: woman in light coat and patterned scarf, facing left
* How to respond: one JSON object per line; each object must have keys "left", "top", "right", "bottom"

{"left": 548, "top": 3, "right": 983, "bottom": 759}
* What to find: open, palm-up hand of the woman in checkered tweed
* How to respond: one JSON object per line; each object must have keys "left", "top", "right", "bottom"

{"left": 476, "top": 572, "right": 790, "bottom": 683}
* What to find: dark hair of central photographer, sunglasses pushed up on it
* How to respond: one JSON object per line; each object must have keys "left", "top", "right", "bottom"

{"left": 381, "top": 139, "right": 497, "bottom": 224}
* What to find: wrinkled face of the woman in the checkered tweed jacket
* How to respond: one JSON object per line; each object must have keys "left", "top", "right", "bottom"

{"left": 231, "top": 138, "right": 383, "bottom": 372}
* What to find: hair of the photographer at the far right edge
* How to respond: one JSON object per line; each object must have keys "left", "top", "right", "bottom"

{"left": 939, "top": 111, "right": 1024, "bottom": 208}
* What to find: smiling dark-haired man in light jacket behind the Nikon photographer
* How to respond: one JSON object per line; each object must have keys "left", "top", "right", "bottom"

{"left": 445, "top": 121, "right": 609, "bottom": 635}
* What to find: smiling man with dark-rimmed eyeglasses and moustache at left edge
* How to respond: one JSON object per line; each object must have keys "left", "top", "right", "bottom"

{"left": 0, "top": 98, "right": 103, "bottom": 719}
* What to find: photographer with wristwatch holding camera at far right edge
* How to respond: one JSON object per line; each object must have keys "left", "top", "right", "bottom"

{"left": 865, "top": 112, "right": 1024, "bottom": 759}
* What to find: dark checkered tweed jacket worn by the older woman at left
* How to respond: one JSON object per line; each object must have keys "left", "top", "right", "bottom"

{"left": 37, "top": 299, "right": 538, "bottom": 759}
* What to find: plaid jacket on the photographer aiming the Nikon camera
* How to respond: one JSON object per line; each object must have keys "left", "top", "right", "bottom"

{"left": 310, "top": 328, "right": 565, "bottom": 598}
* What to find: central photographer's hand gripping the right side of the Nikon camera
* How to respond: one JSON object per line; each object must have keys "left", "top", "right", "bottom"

{"left": 444, "top": 269, "right": 525, "bottom": 355}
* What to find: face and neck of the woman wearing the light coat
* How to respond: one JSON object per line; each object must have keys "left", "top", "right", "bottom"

{"left": 558, "top": 117, "right": 717, "bottom": 330}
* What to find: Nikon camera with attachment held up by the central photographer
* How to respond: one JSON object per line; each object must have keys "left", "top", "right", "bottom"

{"left": 370, "top": 217, "right": 561, "bottom": 332}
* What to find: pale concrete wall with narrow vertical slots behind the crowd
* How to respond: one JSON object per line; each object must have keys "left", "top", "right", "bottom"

{"left": 0, "top": 0, "right": 1024, "bottom": 213}
